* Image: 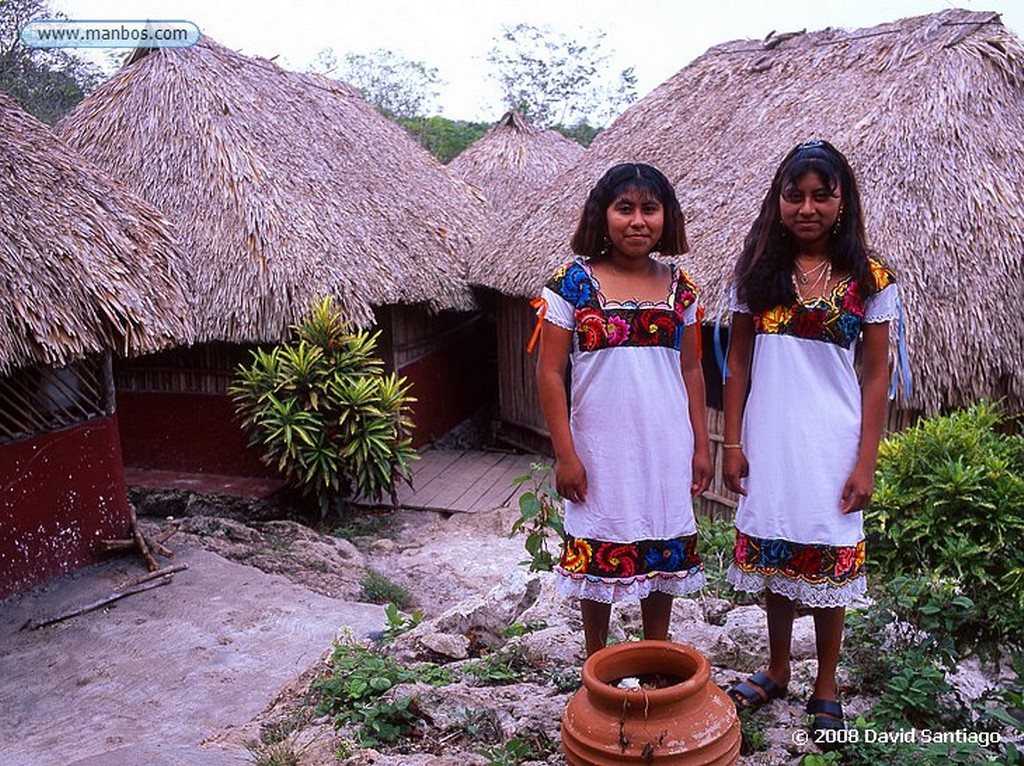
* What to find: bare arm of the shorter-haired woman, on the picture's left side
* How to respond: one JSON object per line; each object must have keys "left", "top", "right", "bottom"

{"left": 537, "top": 322, "right": 587, "bottom": 503}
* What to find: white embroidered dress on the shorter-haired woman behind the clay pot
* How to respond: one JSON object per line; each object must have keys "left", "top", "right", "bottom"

{"left": 543, "top": 258, "right": 705, "bottom": 603}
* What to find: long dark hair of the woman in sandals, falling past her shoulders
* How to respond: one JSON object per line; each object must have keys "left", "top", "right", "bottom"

{"left": 733, "top": 141, "right": 877, "bottom": 313}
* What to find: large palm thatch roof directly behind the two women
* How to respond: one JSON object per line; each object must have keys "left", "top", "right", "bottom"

{"left": 470, "top": 9, "right": 1024, "bottom": 412}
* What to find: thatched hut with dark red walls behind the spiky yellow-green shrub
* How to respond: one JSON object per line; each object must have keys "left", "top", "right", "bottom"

{"left": 56, "top": 38, "right": 491, "bottom": 474}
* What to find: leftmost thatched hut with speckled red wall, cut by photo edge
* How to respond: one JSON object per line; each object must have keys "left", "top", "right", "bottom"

{"left": 0, "top": 93, "right": 193, "bottom": 598}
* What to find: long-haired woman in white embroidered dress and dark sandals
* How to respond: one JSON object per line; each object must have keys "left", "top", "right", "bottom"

{"left": 723, "top": 141, "right": 898, "bottom": 745}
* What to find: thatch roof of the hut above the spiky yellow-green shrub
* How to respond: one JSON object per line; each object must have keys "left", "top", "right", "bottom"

{"left": 56, "top": 38, "right": 484, "bottom": 343}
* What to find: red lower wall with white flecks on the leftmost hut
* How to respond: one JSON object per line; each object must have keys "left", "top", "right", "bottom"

{"left": 0, "top": 416, "right": 130, "bottom": 598}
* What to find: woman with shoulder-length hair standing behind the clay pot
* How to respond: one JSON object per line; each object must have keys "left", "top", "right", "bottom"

{"left": 537, "top": 163, "right": 711, "bottom": 654}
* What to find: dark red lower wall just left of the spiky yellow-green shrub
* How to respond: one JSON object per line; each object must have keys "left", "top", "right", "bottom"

{"left": 117, "top": 391, "right": 278, "bottom": 476}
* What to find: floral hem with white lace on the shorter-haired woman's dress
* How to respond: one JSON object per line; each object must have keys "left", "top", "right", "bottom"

{"left": 555, "top": 535, "right": 705, "bottom": 603}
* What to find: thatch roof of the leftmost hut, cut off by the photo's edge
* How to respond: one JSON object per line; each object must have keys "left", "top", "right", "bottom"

{"left": 0, "top": 93, "right": 193, "bottom": 375}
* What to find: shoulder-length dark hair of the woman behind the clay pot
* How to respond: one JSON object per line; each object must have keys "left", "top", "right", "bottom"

{"left": 570, "top": 162, "right": 689, "bottom": 258}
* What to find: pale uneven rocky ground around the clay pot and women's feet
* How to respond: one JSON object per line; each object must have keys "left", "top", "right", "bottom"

{"left": 145, "top": 498, "right": 868, "bottom": 766}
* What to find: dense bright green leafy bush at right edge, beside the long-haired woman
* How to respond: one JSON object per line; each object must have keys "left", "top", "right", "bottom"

{"left": 865, "top": 402, "right": 1024, "bottom": 647}
